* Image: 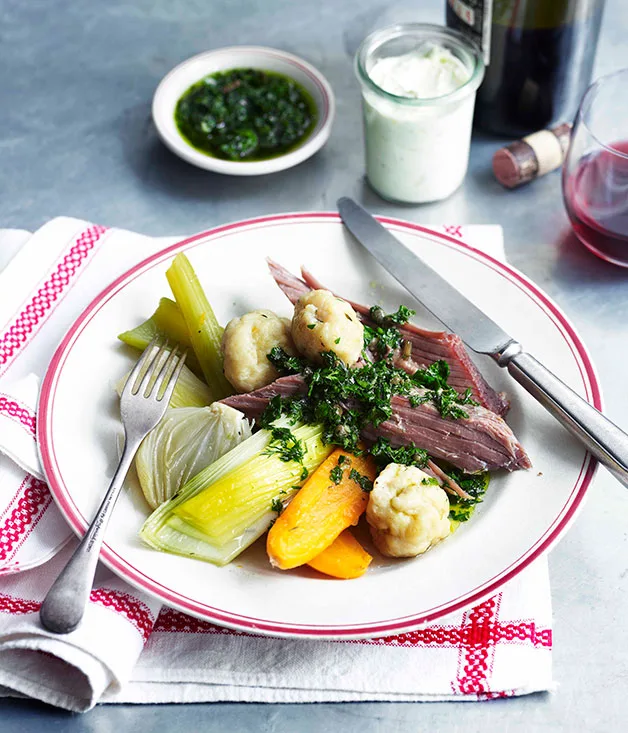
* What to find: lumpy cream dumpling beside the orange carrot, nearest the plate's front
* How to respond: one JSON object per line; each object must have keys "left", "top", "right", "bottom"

{"left": 366, "top": 463, "right": 450, "bottom": 557}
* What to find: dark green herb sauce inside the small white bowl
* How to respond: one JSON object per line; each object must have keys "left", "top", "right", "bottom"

{"left": 174, "top": 69, "right": 318, "bottom": 161}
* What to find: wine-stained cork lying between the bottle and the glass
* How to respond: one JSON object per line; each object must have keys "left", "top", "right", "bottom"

{"left": 493, "top": 122, "right": 571, "bottom": 188}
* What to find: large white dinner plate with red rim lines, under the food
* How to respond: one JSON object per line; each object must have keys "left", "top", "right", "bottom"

{"left": 38, "top": 213, "right": 601, "bottom": 638}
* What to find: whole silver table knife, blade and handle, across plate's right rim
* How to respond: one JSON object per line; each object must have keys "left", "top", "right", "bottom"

{"left": 338, "top": 198, "right": 628, "bottom": 486}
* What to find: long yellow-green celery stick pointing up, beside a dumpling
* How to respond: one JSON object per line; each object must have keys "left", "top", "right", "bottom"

{"left": 166, "top": 252, "right": 233, "bottom": 399}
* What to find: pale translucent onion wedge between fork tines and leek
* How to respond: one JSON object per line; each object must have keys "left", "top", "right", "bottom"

{"left": 135, "top": 403, "right": 251, "bottom": 509}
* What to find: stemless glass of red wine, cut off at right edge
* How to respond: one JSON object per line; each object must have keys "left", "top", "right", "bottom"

{"left": 563, "top": 69, "right": 628, "bottom": 267}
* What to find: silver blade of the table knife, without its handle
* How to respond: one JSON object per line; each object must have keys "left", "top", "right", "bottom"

{"left": 338, "top": 198, "right": 513, "bottom": 355}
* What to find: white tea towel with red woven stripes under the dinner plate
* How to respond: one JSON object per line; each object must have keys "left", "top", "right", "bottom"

{"left": 0, "top": 219, "right": 552, "bottom": 711}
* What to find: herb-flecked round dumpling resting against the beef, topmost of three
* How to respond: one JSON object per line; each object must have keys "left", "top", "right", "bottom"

{"left": 292, "top": 290, "right": 364, "bottom": 366}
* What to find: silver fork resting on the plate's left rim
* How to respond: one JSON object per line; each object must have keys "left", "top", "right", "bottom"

{"left": 39, "top": 338, "right": 186, "bottom": 634}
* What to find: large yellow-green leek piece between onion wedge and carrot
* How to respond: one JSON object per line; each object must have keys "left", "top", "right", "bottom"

{"left": 140, "top": 421, "right": 333, "bottom": 565}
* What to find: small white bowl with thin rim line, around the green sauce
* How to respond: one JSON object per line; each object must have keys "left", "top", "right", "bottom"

{"left": 153, "top": 46, "right": 336, "bottom": 176}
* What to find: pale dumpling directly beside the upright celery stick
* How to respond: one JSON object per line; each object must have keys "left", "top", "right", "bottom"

{"left": 222, "top": 310, "right": 296, "bottom": 392}
